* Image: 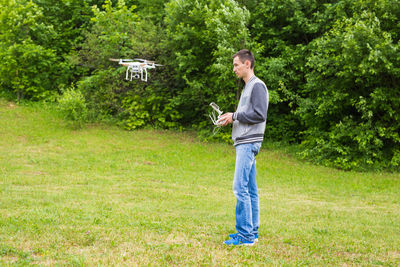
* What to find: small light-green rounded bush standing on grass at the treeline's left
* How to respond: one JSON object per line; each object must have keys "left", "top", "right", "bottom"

{"left": 58, "top": 87, "right": 88, "bottom": 128}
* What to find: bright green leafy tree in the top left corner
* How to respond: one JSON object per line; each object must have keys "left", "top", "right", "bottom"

{"left": 0, "top": 0, "right": 62, "bottom": 100}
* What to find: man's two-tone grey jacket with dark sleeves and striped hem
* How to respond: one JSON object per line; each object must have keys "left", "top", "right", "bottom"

{"left": 232, "top": 76, "right": 269, "bottom": 146}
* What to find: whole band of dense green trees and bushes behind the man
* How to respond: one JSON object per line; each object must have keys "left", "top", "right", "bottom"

{"left": 0, "top": 0, "right": 400, "bottom": 170}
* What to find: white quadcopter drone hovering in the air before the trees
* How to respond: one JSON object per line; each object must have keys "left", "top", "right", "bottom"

{"left": 110, "top": 58, "right": 162, "bottom": 82}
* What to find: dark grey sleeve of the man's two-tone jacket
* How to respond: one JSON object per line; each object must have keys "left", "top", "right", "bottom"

{"left": 233, "top": 83, "right": 268, "bottom": 124}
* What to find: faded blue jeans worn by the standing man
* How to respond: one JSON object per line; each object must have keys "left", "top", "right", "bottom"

{"left": 233, "top": 142, "right": 261, "bottom": 241}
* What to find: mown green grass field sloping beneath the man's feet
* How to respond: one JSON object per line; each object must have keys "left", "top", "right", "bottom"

{"left": 0, "top": 100, "right": 400, "bottom": 266}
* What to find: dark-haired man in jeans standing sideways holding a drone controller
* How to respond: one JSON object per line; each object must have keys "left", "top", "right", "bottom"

{"left": 218, "top": 49, "right": 269, "bottom": 246}
